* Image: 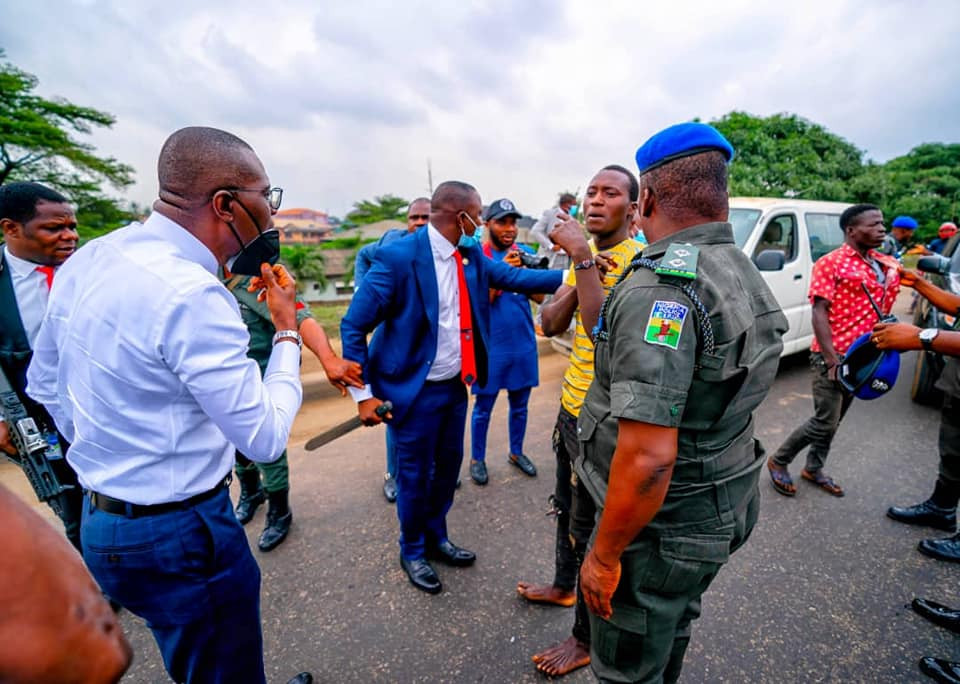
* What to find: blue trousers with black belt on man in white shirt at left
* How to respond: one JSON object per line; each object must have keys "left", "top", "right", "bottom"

{"left": 81, "top": 487, "right": 266, "bottom": 684}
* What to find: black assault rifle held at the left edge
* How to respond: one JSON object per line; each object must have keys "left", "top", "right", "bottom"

{"left": 0, "top": 368, "right": 73, "bottom": 518}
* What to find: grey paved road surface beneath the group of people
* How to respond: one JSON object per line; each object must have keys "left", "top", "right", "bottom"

{"left": 4, "top": 318, "right": 960, "bottom": 682}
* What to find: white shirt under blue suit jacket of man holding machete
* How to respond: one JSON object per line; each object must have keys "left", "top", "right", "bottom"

{"left": 347, "top": 223, "right": 460, "bottom": 403}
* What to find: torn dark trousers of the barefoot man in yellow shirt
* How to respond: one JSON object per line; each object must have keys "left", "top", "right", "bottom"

{"left": 553, "top": 407, "right": 597, "bottom": 645}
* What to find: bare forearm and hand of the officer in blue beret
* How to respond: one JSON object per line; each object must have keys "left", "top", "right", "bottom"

{"left": 580, "top": 418, "right": 677, "bottom": 619}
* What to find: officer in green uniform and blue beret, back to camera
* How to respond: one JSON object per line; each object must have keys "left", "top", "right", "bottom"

{"left": 550, "top": 123, "right": 787, "bottom": 682}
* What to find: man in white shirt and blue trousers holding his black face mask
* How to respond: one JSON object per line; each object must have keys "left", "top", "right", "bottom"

{"left": 27, "top": 127, "right": 312, "bottom": 684}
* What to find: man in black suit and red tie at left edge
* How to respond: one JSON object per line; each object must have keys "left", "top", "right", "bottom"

{"left": 0, "top": 183, "right": 83, "bottom": 550}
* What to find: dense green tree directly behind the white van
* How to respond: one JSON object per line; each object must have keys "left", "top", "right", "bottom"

{"left": 711, "top": 111, "right": 863, "bottom": 201}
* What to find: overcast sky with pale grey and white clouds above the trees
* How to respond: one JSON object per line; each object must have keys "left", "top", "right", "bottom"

{"left": 0, "top": 0, "right": 960, "bottom": 216}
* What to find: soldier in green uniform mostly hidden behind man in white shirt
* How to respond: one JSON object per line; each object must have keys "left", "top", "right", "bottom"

{"left": 223, "top": 268, "right": 363, "bottom": 551}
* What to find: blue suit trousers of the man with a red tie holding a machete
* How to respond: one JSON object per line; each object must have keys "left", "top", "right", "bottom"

{"left": 393, "top": 378, "right": 467, "bottom": 560}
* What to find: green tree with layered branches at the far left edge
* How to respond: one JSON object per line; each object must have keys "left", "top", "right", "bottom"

{"left": 0, "top": 50, "right": 133, "bottom": 232}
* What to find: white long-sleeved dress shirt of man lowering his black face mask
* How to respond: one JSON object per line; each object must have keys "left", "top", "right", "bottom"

{"left": 27, "top": 212, "right": 302, "bottom": 504}
